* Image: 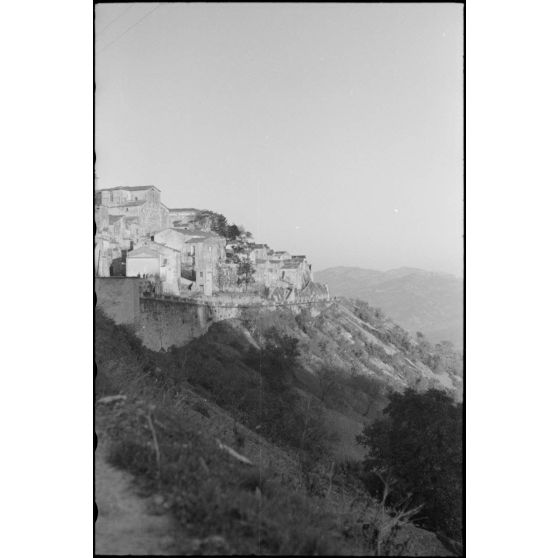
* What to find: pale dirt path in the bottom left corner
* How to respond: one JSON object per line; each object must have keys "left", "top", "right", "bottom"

{"left": 95, "top": 445, "right": 174, "bottom": 555}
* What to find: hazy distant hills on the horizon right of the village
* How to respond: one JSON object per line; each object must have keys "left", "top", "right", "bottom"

{"left": 314, "top": 267, "right": 463, "bottom": 349}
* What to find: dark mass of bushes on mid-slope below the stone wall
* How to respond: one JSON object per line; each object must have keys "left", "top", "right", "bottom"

{"left": 170, "top": 323, "right": 331, "bottom": 456}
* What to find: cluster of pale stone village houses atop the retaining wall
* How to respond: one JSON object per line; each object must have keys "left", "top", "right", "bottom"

{"left": 95, "top": 186, "right": 312, "bottom": 296}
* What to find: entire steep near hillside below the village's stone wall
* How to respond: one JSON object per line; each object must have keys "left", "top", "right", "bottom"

{"left": 95, "top": 300, "right": 461, "bottom": 556}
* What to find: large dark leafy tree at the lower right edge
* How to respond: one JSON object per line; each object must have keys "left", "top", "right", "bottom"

{"left": 359, "top": 389, "right": 463, "bottom": 540}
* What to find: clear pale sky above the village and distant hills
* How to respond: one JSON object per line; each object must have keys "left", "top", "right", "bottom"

{"left": 95, "top": 3, "right": 464, "bottom": 276}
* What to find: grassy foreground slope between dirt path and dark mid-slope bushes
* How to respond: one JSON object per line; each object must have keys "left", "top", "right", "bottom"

{"left": 96, "top": 317, "right": 343, "bottom": 554}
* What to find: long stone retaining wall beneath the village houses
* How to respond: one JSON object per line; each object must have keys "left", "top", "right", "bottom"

{"left": 95, "top": 277, "right": 329, "bottom": 351}
